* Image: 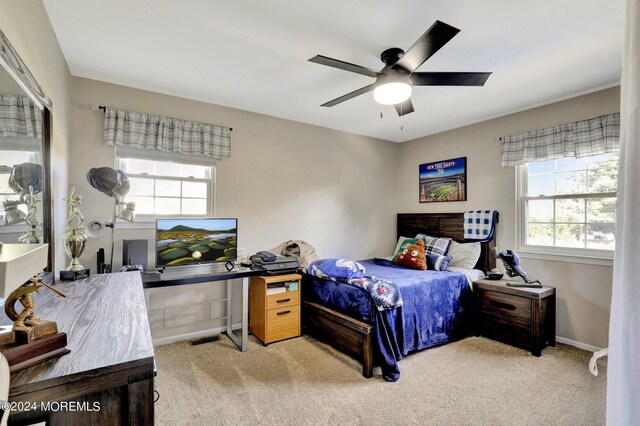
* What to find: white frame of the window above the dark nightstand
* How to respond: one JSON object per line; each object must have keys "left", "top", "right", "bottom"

{"left": 516, "top": 164, "right": 617, "bottom": 266}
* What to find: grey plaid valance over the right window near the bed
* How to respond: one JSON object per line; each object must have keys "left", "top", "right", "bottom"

{"left": 501, "top": 113, "right": 620, "bottom": 167}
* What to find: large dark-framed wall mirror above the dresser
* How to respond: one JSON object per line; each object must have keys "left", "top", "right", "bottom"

{"left": 0, "top": 32, "right": 55, "bottom": 271}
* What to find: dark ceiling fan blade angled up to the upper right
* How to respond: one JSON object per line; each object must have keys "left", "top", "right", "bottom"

{"left": 391, "top": 21, "right": 460, "bottom": 73}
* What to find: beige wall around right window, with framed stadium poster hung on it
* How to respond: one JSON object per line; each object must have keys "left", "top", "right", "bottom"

{"left": 397, "top": 87, "right": 620, "bottom": 347}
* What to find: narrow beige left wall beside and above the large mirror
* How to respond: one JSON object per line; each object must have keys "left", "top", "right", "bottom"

{"left": 0, "top": 0, "right": 71, "bottom": 269}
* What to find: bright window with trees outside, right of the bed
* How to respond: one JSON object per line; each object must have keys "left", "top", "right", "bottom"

{"left": 518, "top": 154, "right": 618, "bottom": 255}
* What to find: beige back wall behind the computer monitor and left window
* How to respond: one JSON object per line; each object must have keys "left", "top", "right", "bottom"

{"left": 69, "top": 77, "right": 398, "bottom": 270}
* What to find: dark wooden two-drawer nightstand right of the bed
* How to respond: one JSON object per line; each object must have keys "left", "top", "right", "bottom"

{"left": 473, "top": 280, "right": 556, "bottom": 356}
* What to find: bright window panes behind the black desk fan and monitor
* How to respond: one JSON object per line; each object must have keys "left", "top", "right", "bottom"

{"left": 118, "top": 158, "right": 213, "bottom": 216}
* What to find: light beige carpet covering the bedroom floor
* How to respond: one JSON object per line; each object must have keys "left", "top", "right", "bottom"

{"left": 155, "top": 336, "right": 607, "bottom": 425}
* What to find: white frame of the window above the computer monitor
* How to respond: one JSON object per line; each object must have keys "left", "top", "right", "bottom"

{"left": 115, "top": 155, "right": 216, "bottom": 223}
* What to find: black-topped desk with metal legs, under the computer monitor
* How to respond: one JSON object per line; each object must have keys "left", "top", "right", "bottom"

{"left": 142, "top": 267, "right": 264, "bottom": 352}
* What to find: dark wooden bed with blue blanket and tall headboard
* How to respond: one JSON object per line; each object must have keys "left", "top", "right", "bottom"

{"left": 302, "top": 213, "right": 495, "bottom": 381}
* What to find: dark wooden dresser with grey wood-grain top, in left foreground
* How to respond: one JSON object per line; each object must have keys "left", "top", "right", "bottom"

{"left": 0, "top": 272, "right": 155, "bottom": 425}
